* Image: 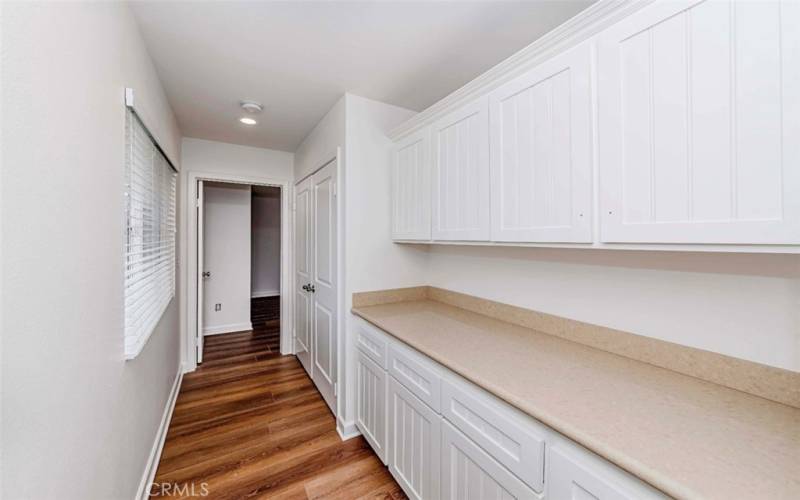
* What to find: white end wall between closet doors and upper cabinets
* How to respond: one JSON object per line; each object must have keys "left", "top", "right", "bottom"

{"left": 340, "top": 94, "right": 427, "bottom": 430}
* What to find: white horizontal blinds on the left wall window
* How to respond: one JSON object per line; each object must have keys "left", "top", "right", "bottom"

{"left": 125, "top": 108, "right": 177, "bottom": 359}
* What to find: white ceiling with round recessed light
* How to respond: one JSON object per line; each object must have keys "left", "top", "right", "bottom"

{"left": 132, "top": 0, "right": 592, "bottom": 151}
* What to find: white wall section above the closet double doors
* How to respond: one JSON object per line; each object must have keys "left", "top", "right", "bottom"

{"left": 294, "top": 96, "right": 345, "bottom": 181}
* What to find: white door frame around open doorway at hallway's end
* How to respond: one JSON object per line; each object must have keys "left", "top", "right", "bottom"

{"left": 184, "top": 172, "right": 294, "bottom": 372}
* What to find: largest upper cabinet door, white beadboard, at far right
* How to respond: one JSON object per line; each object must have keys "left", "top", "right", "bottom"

{"left": 598, "top": 0, "right": 800, "bottom": 244}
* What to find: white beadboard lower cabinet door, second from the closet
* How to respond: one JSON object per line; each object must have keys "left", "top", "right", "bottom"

{"left": 389, "top": 377, "right": 441, "bottom": 500}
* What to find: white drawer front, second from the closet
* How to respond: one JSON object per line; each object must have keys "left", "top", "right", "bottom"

{"left": 389, "top": 343, "right": 442, "bottom": 413}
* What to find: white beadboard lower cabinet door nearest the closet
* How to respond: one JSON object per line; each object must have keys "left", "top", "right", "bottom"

{"left": 356, "top": 352, "right": 389, "bottom": 464}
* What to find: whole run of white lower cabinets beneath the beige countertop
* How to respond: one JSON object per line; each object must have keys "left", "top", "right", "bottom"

{"left": 356, "top": 320, "right": 667, "bottom": 500}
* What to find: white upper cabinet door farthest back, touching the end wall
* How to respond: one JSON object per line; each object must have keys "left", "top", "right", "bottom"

{"left": 392, "top": 127, "right": 431, "bottom": 240}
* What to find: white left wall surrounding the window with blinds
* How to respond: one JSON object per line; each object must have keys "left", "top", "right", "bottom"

{"left": 0, "top": 2, "right": 180, "bottom": 499}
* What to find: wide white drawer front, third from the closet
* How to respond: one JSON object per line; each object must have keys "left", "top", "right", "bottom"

{"left": 441, "top": 379, "right": 545, "bottom": 492}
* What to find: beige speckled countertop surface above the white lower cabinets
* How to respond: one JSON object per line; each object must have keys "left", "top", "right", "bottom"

{"left": 353, "top": 300, "right": 800, "bottom": 500}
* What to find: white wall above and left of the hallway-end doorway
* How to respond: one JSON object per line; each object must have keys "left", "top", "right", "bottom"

{"left": 178, "top": 138, "right": 294, "bottom": 369}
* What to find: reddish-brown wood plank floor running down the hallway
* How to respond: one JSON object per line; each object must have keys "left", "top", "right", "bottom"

{"left": 151, "top": 298, "right": 405, "bottom": 499}
